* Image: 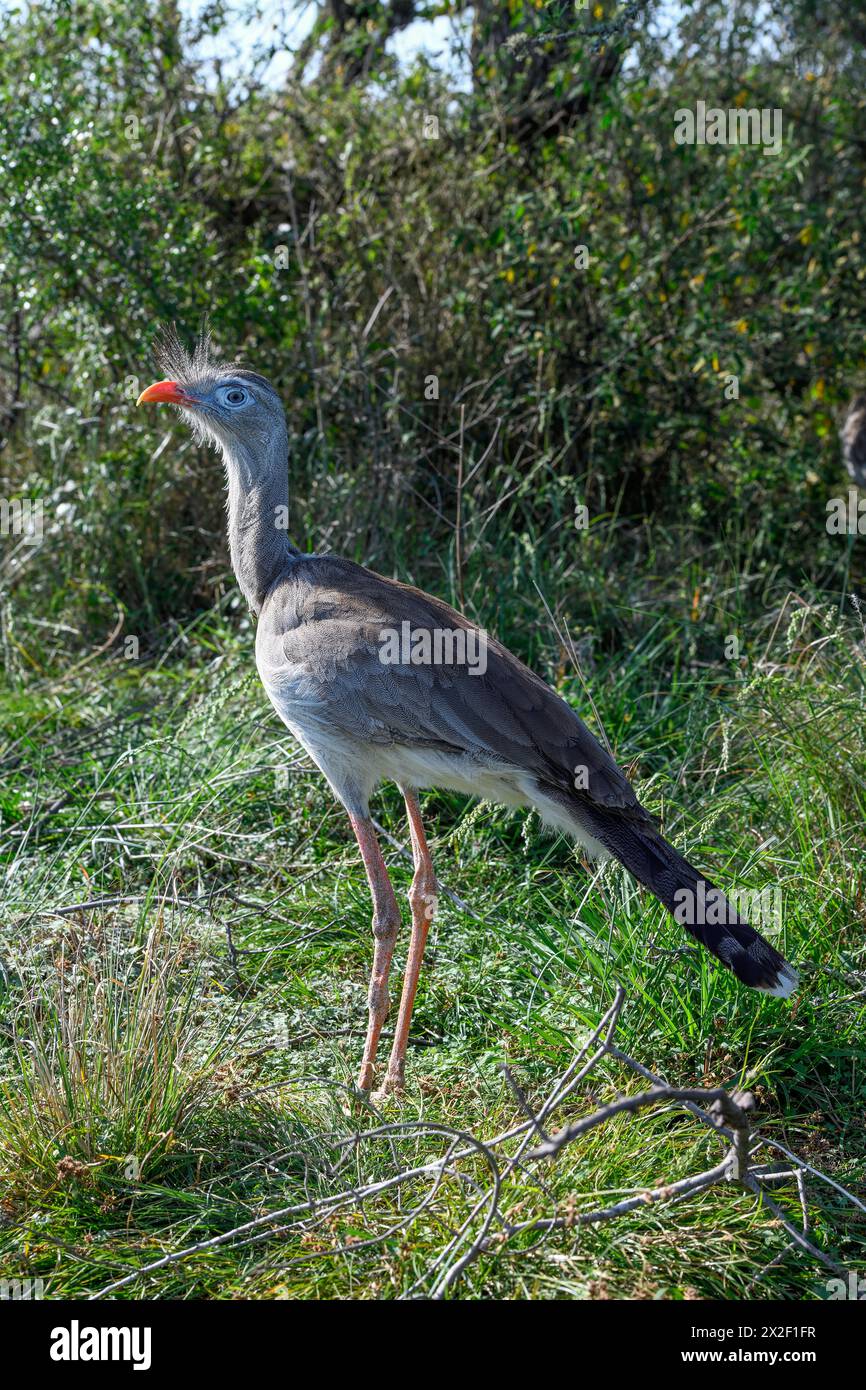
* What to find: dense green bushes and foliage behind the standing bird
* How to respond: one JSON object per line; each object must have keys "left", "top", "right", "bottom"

{"left": 0, "top": 0, "right": 866, "bottom": 671}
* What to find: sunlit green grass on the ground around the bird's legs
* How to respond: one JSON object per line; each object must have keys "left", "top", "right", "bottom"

{"left": 0, "top": 558, "right": 866, "bottom": 1298}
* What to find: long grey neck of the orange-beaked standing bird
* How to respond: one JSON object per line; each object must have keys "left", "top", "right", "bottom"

{"left": 222, "top": 421, "right": 300, "bottom": 614}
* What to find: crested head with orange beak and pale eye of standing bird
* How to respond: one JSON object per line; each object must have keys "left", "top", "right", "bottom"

{"left": 136, "top": 329, "right": 285, "bottom": 466}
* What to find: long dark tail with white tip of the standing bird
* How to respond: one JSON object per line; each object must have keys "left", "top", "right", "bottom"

{"left": 581, "top": 808, "right": 799, "bottom": 999}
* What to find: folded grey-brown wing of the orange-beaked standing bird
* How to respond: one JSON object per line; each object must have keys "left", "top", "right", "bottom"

{"left": 257, "top": 556, "right": 645, "bottom": 817}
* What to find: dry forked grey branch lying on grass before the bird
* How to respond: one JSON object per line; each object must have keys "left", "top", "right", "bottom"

{"left": 84, "top": 988, "right": 863, "bottom": 1300}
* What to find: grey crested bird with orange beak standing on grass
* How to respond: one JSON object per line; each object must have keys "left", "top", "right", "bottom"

{"left": 139, "top": 334, "right": 798, "bottom": 1093}
